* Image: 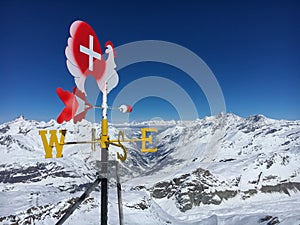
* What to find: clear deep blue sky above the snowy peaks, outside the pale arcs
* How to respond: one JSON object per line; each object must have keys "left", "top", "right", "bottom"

{"left": 0, "top": 0, "right": 300, "bottom": 122}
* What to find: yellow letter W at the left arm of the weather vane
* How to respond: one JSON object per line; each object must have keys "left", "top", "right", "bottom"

{"left": 39, "top": 130, "right": 67, "bottom": 158}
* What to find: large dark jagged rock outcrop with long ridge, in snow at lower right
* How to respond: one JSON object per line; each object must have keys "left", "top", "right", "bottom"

{"left": 150, "top": 168, "right": 300, "bottom": 212}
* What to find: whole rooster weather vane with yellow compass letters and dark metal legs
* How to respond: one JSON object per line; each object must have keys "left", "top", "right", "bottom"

{"left": 39, "top": 21, "right": 157, "bottom": 225}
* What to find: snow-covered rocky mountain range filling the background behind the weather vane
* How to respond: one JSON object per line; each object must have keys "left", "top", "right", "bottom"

{"left": 0, "top": 114, "right": 300, "bottom": 225}
